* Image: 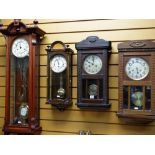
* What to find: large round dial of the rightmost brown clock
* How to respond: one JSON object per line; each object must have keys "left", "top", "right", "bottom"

{"left": 125, "top": 57, "right": 149, "bottom": 80}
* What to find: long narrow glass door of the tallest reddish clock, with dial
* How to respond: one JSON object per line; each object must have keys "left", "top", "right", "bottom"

{"left": 10, "top": 39, "right": 29, "bottom": 125}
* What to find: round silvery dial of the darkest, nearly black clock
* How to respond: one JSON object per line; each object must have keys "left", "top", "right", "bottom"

{"left": 83, "top": 55, "right": 102, "bottom": 74}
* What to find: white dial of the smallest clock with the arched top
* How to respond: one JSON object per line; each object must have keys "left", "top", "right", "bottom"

{"left": 50, "top": 55, "right": 67, "bottom": 73}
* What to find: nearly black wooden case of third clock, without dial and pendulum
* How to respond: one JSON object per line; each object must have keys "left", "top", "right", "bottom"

{"left": 75, "top": 36, "right": 111, "bottom": 109}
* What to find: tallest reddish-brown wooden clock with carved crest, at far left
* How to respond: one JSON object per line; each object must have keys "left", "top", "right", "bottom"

{"left": 0, "top": 20, "right": 45, "bottom": 134}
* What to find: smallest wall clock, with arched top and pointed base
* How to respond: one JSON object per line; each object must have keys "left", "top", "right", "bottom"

{"left": 46, "top": 41, "right": 73, "bottom": 111}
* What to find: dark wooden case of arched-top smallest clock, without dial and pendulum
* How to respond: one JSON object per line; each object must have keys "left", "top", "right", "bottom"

{"left": 46, "top": 41, "right": 73, "bottom": 111}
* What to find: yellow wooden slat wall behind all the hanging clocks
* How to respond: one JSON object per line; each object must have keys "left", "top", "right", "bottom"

{"left": 0, "top": 19, "right": 155, "bottom": 135}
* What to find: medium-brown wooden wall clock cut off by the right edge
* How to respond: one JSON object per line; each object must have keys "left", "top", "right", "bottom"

{"left": 117, "top": 41, "right": 155, "bottom": 123}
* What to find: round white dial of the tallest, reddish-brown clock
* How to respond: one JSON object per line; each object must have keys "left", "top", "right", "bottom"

{"left": 12, "top": 38, "right": 29, "bottom": 58}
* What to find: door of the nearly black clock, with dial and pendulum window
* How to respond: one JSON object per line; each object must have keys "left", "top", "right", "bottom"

{"left": 82, "top": 53, "right": 104, "bottom": 100}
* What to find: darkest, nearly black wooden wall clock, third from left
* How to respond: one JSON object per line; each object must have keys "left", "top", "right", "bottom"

{"left": 75, "top": 36, "right": 111, "bottom": 109}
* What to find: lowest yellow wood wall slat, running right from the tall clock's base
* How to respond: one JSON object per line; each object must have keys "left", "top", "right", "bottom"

{"left": 41, "top": 120, "right": 155, "bottom": 135}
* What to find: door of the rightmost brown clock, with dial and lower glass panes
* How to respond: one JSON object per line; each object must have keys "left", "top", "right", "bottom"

{"left": 122, "top": 54, "right": 151, "bottom": 112}
